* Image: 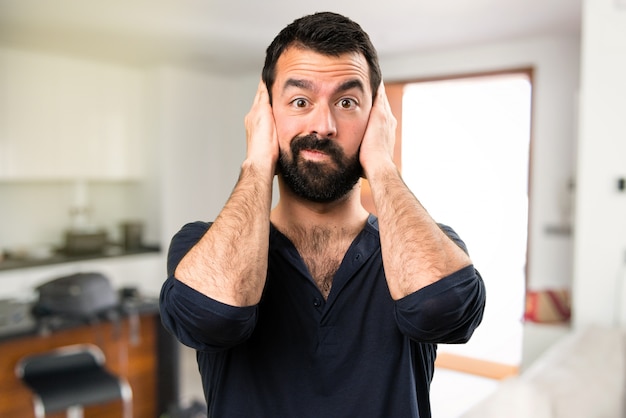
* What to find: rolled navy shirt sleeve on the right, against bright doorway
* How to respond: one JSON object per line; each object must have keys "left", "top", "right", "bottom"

{"left": 395, "top": 225, "right": 486, "bottom": 344}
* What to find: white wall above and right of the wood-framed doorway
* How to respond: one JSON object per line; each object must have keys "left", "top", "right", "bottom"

{"left": 381, "top": 37, "right": 579, "bottom": 289}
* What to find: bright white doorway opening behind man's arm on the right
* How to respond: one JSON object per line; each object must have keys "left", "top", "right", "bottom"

{"left": 391, "top": 70, "right": 532, "bottom": 372}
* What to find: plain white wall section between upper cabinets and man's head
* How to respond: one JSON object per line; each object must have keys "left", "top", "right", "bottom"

{"left": 150, "top": 67, "right": 258, "bottom": 248}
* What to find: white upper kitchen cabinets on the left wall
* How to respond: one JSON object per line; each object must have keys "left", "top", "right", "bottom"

{"left": 0, "top": 49, "right": 144, "bottom": 180}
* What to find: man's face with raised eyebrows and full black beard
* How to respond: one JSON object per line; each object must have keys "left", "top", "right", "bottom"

{"left": 272, "top": 47, "right": 372, "bottom": 203}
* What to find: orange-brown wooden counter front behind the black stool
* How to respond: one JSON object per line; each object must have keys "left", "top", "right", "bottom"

{"left": 0, "top": 311, "right": 166, "bottom": 418}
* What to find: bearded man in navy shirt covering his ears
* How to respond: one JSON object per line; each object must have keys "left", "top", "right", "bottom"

{"left": 161, "top": 13, "right": 485, "bottom": 418}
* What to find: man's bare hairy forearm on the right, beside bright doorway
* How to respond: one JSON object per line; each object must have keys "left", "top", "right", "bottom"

{"left": 368, "top": 163, "right": 471, "bottom": 300}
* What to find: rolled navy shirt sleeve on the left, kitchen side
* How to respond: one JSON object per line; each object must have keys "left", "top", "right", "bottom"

{"left": 159, "top": 222, "right": 257, "bottom": 352}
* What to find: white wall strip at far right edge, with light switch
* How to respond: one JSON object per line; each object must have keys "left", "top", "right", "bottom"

{"left": 573, "top": 0, "right": 626, "bottom": 326}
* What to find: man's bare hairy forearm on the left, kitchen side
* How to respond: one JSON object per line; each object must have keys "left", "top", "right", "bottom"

{"left": 175, "top": 162, "right": 273, "bottom": 306}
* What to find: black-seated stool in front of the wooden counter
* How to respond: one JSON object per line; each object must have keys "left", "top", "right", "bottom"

{"left": 15, "top": 344, "right": 132, "bottom": 418}
